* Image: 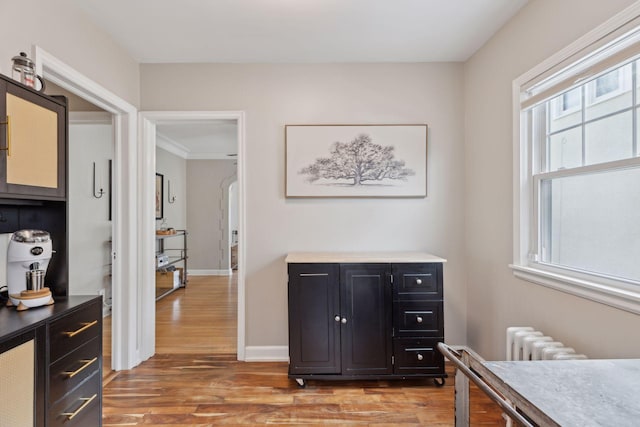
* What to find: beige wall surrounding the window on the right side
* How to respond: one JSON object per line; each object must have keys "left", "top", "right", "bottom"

{"left": 464, "top": 0, "right": 640, "bottom": 358}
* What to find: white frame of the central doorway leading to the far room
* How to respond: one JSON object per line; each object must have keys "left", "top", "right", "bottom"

{"left": 138, "top": 111, "right": 247, "bottom": 360}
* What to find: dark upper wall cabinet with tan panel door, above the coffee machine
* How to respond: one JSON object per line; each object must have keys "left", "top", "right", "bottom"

{"left": 0, "top": 75, "right": 67, "bottom": 200}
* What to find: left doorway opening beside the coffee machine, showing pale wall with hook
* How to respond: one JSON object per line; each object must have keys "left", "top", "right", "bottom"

{"left": 65, "top": 108, "right": 114, "bottom": 377}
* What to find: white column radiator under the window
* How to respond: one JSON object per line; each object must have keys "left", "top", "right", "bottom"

{"left": 506, "top": 326, "right": 587, "bottom": 360}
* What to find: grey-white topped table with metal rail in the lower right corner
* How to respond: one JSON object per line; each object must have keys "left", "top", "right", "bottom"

{"left": 438, "top": 344, "right": 640, "bottom": 427}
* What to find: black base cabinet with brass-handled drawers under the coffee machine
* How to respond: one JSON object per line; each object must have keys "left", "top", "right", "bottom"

{"left": 0, "top": 296, "right": 102, "bottom": 427}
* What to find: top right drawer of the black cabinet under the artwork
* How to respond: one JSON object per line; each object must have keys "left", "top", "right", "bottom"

{"left": 393, "top": 263, "right": 442, "bottom": 301}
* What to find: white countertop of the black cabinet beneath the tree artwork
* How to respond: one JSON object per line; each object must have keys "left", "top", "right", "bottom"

{"left": 285, "top": 252, "right": 447, "bottom": 263}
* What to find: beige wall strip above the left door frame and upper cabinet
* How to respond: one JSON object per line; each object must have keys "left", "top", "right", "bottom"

{"left": 0, "top": 0, "right": 140, "bottom": 106}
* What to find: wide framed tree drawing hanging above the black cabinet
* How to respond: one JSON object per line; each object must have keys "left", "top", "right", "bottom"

{"left": 285, "top": 124, "right": 428, "bottom": 197}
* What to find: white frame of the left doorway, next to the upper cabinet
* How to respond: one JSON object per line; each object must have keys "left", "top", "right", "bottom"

{"left": 32, "top": 45, "right": 141, "bottom": 370}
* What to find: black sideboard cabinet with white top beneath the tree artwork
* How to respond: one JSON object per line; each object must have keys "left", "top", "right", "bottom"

{"left": 287, "top": 253, "right": 446, "bottom": 386}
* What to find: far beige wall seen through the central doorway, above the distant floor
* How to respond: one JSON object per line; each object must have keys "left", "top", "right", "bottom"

{"left": 187, "top": 160, "right": 236, "bottom": 274}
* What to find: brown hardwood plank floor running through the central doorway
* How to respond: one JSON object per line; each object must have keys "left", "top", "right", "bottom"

{"left": 103, "top": 277, "right": 504, "bottom": 427}
